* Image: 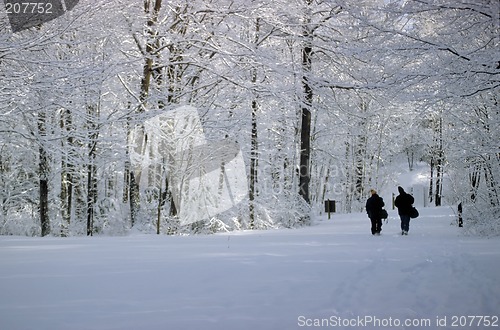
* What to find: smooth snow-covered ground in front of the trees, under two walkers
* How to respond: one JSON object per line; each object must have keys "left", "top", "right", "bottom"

{"left": 0, "top": 207, "right": 500, "bottom": 330}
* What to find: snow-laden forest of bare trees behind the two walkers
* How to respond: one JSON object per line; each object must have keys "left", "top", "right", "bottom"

{"left": 0, "top": 0, "right": 500, "bottom": 237}
